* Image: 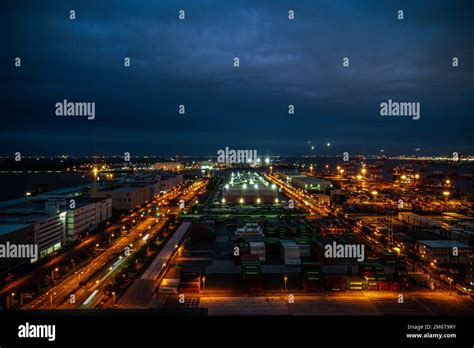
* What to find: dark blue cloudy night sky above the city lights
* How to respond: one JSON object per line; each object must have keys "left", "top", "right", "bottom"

{"left": 0, "top": 0, "right": 474, "bottom": 156}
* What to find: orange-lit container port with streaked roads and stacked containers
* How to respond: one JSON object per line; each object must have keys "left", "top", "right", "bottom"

{"left": 2, "top": 163, "right": 474, "bottom": 316}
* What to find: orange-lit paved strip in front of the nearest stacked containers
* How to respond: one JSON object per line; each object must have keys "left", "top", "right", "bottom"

{"left": 200, "top": 292, "right": 474, "bottom": 316}
